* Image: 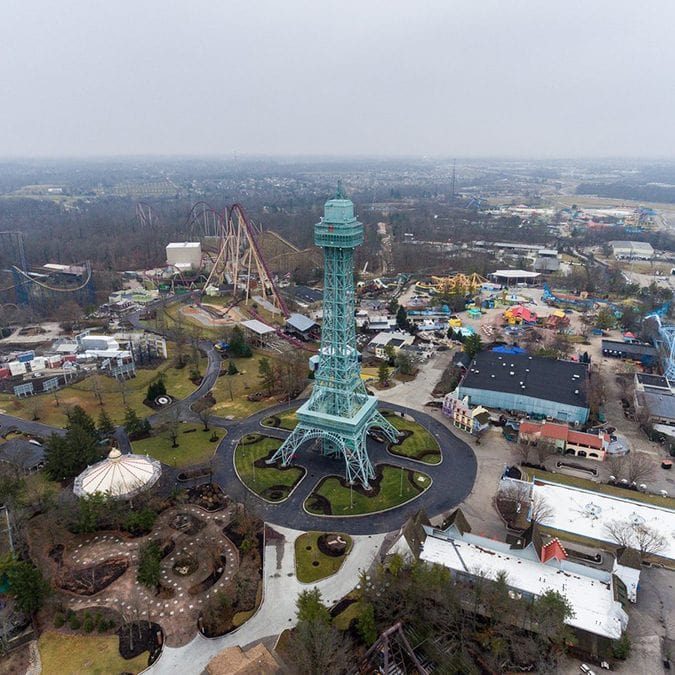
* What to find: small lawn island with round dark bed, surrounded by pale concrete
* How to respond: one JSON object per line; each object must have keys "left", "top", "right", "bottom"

{"left": 295, "top": 532, "right": 352, "bottom": 584}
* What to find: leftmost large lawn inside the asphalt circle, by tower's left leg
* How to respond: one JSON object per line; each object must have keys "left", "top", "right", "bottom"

{"left": 234, "top": 436, "right": 304, "bottom": 502}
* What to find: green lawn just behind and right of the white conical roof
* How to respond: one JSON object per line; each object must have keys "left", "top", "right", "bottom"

{"left": 132, "top": 424, "right": 220, "bottom": 467}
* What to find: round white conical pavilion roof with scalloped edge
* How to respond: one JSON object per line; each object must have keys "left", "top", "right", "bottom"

{"left": 73, "top": 448, "right": 162, "bottom": 498}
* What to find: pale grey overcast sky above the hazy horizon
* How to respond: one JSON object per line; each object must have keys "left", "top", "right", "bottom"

{"left": 0, "top": 0, "right": 675, "bottom": 158}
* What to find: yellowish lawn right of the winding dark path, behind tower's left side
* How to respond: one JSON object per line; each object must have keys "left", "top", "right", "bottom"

{"left": 211, "top": 353, "right": 284, "bottom": 419}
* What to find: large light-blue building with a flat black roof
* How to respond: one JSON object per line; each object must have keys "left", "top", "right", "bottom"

{"left": 457, "top": 352, "right": 589, "bottom": 424}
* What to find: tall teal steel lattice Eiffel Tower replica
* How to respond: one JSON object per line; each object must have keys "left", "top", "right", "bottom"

{"left": 269, "top": 184, "right": 398, "bottom": 488}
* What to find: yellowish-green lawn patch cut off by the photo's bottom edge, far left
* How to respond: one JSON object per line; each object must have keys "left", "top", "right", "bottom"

{"left": 38, "top": 630, "right": 148, "bottom": 675}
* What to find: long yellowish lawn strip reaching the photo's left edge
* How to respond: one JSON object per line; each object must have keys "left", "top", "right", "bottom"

{"left": 0, "top": 345, "right": 206, "bottom": 427}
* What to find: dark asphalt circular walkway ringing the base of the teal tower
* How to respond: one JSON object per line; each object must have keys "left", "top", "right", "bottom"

{"left": 209, "top": 401, "right": 477, "bottom": 534}
